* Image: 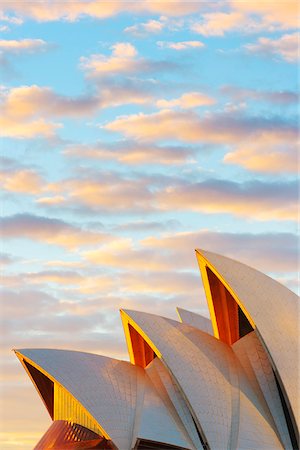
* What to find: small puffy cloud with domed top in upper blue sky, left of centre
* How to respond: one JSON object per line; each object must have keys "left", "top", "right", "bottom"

{"left": 80, "top": 42, "right": 175, "bottom": 78}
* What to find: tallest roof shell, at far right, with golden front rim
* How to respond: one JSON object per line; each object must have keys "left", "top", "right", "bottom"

{"left": 196, "top": 249, "right": 300, "bottom": 429}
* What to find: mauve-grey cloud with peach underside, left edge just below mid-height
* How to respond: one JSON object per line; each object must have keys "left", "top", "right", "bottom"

{"left": 0, "top": 214, "right": 109, "bottom": 250}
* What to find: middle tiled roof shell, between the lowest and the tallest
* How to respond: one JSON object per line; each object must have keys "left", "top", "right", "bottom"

{"left": 122, "top": 310, "right": 283, "bottom": 450}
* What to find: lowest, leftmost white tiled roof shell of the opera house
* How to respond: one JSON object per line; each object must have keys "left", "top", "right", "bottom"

{"left": 16, "top": 349, "right": 194, "bottom": 450}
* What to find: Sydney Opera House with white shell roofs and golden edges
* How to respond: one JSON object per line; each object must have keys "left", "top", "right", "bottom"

{"left": 15, "top": 250, "right": 300, "bottom": 450}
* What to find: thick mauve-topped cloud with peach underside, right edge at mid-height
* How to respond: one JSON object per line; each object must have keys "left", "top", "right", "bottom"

{"left": 156, "top": 179, "right": 298, "bottom": 220}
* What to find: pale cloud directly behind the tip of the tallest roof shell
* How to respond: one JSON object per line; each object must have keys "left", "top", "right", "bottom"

{"left": 141, "top": 229, "right": 298, "bottom": 273}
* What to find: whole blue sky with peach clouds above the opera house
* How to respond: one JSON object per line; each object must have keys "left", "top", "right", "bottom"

{"left": 0, "top": 0, "right": 299, "bottom": 450}
